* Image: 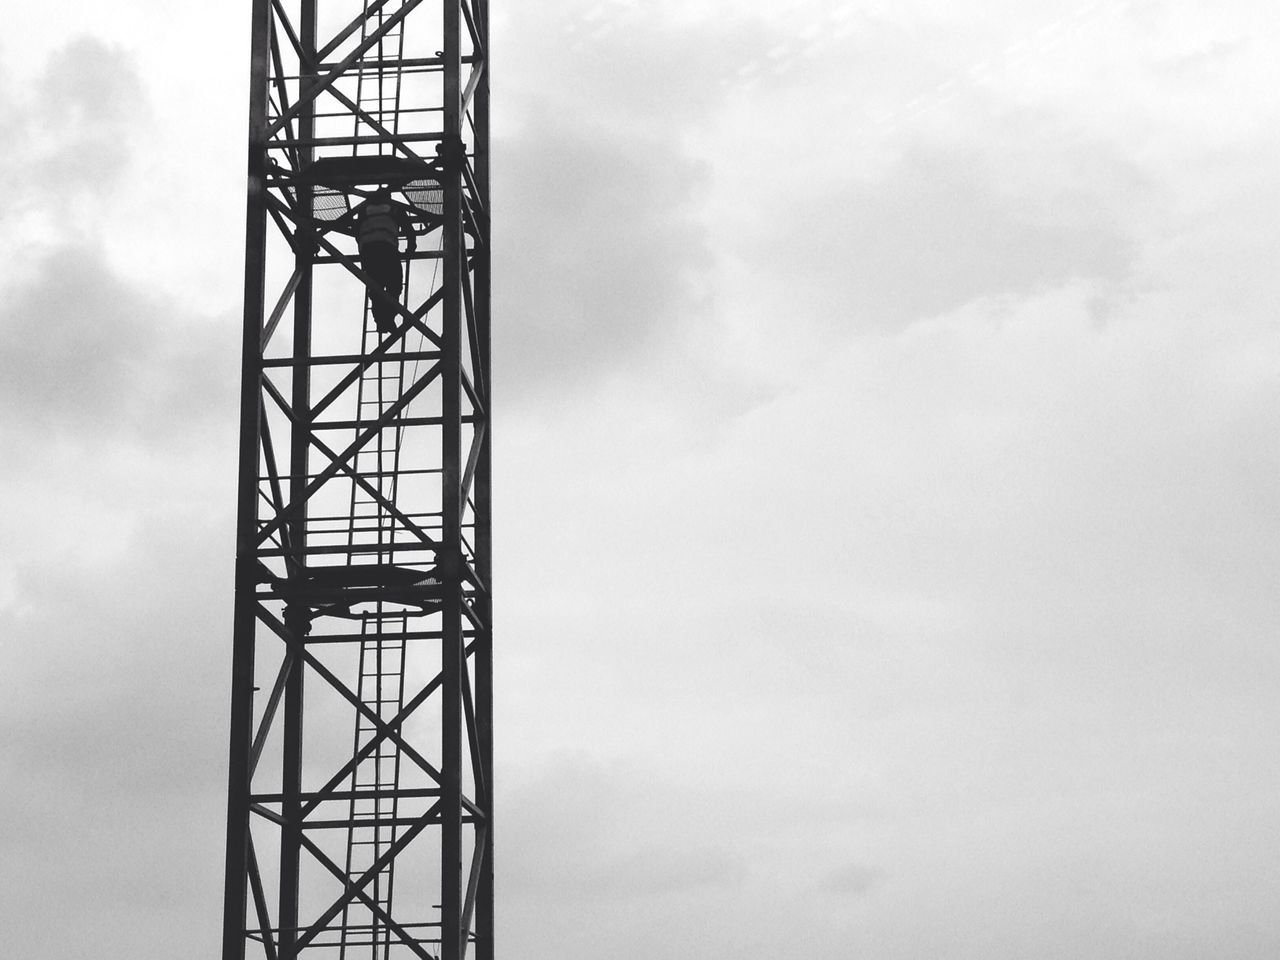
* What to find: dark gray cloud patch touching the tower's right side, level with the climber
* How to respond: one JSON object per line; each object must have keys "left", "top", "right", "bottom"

{"left": 495, "top": 115, "right": 708, "bottom": 390}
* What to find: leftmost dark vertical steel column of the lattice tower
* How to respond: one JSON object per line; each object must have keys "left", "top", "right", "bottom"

{"left": 223, "top": 0, "right": 270, "bottom": 960}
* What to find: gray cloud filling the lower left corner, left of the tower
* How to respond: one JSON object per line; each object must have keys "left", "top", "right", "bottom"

{"left": 0, "top": 512, "right": 230, "bottom": 957}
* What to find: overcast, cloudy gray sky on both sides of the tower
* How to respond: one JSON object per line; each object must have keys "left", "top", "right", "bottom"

{"left": 0, "top": 0, "right": 1280, "bottom": 960}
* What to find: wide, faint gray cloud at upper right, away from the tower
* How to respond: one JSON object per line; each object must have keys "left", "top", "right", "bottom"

{"left": 751, "top": 133, "right": 1132, "bottom": 330}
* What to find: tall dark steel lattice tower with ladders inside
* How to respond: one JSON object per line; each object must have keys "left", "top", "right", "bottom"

{"left": 223, "top": 0, "right": 493, "bottom": 960}
